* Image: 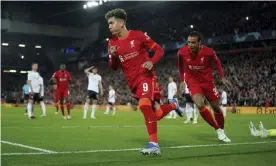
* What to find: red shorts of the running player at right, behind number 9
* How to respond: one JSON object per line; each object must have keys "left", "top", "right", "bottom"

{"left": 187, "top": 82, "right": 220, "bottom": 102}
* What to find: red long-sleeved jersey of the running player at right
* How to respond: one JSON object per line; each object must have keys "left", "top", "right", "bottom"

{"left": 178, "top": 46, "right": 224, "bottom": 83}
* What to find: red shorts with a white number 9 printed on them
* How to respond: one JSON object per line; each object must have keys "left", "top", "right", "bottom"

{"left": 131, "top": 77, "right": 155, "bottom": 101}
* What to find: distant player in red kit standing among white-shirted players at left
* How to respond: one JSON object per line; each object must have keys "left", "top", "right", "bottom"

{"left": 52, "top": 64, "right": 71, "bottom": 119}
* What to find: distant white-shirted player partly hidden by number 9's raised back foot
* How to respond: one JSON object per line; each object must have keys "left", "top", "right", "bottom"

{"left": 167, "top": 77, "right": 177, "bottom": 119}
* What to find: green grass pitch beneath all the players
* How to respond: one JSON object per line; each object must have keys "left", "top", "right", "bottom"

{"left": 1, "top": 107, "right": 276, "bottom": 166}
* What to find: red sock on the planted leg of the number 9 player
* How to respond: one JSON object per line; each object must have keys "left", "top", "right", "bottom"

{"left": 139, "top": 99, "right": 158, "bottom": 143}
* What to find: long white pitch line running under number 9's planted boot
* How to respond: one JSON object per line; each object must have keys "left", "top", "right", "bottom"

{"left": 1, "top": 141, "right": 276, "bottom": 156}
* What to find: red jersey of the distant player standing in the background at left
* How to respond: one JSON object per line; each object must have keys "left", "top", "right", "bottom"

{"left": 52, "top": 70, "right": 71, "bottom": 91}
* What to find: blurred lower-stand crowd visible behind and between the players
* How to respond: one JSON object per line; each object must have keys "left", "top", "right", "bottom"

{"left": 2, "top": 52, "right": 276, "bottom": 106}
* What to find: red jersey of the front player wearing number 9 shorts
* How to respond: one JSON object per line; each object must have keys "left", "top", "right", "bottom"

{"left": 108, "top": 30, "right": 164, "bottom": 89}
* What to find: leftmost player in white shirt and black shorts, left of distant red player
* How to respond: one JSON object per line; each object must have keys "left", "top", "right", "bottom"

{"left": 27, "top": 63, "right": 41, "bottom": 119}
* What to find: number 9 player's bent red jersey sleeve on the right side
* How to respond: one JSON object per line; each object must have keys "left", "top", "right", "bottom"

{"left": 137, "top": 31, "right": 164, "bottom": 64}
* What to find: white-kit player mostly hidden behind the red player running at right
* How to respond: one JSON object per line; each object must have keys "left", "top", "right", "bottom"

{"left": 184, "top": 81, "right": 198, "bottom": 124}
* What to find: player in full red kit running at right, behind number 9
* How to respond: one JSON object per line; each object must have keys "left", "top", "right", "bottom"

{"left": 178, "top": 31, "right": 232, "bottom": 142}
